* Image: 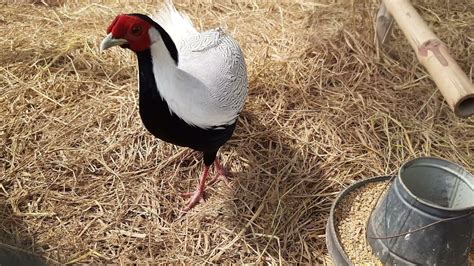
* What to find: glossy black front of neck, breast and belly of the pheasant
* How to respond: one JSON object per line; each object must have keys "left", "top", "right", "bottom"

{"left": 137, "top": 50, "right": 235, "bottom": 151}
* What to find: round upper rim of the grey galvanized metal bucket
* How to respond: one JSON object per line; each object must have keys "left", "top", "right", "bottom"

{"left": 396, "top": 156, "right": 474, "bottom": 213}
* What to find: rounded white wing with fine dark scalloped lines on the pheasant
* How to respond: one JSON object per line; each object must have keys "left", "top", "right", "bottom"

{"left": 178, "top": 30, "right": 247, "bottom": 116}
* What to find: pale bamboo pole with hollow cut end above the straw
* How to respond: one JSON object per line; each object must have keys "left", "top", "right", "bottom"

{"left": 377, "top": 0, "right": 474, "bottom": 117}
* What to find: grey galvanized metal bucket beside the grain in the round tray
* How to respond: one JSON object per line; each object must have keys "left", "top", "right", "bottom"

{"left": 367, "top": 157, "right": 474, "bottom": 265}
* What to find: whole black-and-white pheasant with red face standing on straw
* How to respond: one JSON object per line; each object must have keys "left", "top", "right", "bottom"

{"left": 100, "top": 0, "right": 248, "bottom": 211}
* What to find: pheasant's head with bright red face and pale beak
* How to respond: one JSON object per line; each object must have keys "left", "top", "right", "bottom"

{"left": 100, "top": 14, "right": 152, "bottom": 52}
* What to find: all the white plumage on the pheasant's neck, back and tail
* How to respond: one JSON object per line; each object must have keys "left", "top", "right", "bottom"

{"left": 149, "top": 1, "right": 248, "bottom": 128}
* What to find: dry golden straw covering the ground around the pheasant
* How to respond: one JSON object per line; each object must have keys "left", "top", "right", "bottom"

{"left": 0, "top": 0, "right": 474, "bottom": 263}
